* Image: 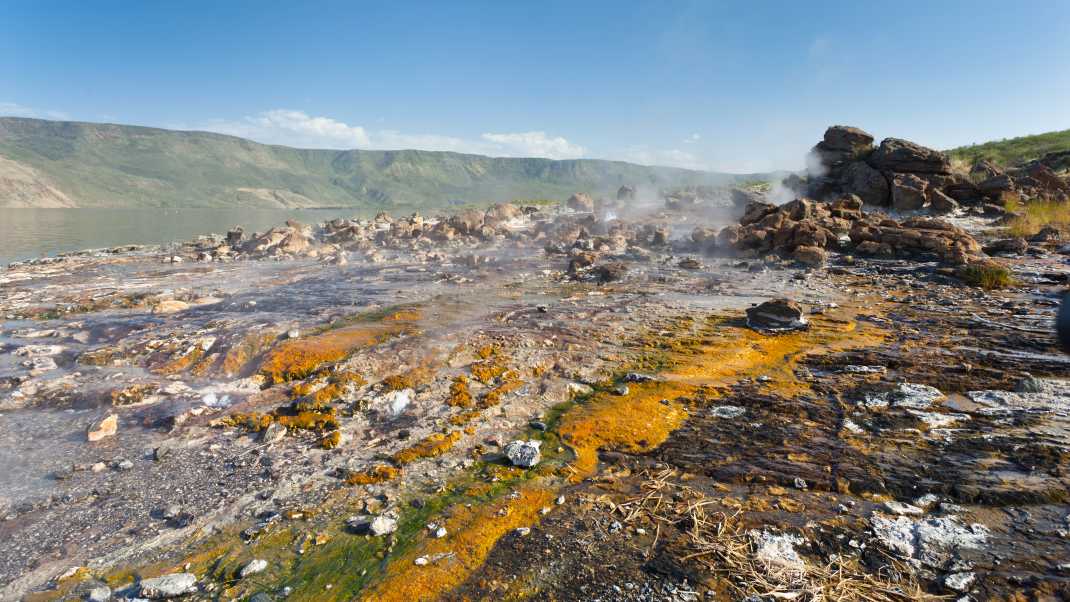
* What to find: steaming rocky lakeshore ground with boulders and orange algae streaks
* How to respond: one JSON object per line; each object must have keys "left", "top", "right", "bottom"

{"left": 0, "top": 126, "right": 1070, "bottom": 602}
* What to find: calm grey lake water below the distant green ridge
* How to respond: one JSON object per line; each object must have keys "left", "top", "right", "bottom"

{"left": 0, "top": 209, "right": 369, "bottom": 266}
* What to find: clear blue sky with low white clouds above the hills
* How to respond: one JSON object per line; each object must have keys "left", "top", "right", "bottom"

{"left": 0, "top": 0, "right": 1070, "bottom": 172}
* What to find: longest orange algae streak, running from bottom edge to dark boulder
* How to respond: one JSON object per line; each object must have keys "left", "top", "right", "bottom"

{"left": 364, "top": 307, "right": 885, "bottom": 602}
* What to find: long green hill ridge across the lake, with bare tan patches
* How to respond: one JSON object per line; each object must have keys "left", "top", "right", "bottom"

{"left": 0, "top": 118, "right": 753, "bottom": 209}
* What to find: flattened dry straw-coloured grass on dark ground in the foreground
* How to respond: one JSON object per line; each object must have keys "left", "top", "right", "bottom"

{"left": 618, "top": 469, "right": 938, "bottom": 602}
